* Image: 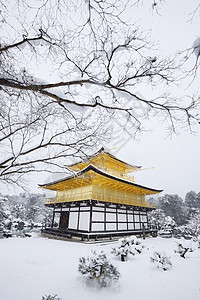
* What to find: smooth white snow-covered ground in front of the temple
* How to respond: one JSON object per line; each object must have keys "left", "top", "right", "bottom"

{"left": 0, "top": 237, "right": 200, "bottom": 300}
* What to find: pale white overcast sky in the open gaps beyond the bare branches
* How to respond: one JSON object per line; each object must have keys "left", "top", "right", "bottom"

{"left": 2, "top": 0, "right": 200, "bottom": 197}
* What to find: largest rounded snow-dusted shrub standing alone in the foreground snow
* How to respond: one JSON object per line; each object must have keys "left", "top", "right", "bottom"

{"left": 78, "top": 251, "right": 120, "bottom": 287}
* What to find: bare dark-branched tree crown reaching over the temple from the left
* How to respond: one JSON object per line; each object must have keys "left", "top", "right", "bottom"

{"left": 0, "top": 0, "right": 199, "bottom": 185}
